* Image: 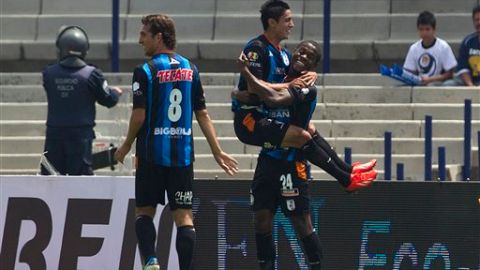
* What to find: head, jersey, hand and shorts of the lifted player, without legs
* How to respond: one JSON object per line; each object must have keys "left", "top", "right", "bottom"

{"left": 232, "top": 0, "right": 317, "bottom": 146}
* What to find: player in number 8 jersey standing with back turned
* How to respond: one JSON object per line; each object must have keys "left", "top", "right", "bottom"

{"left": 115, "top": 15, "right": 238, "bottom": 270}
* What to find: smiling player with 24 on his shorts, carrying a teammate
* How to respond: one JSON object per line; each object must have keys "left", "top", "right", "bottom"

{"left": 240, "top": 41, "right": 374, "bottom": 270}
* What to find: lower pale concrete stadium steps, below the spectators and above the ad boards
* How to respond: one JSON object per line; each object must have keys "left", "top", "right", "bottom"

{"left": 0, "top": 73, "right": 480, "bottom": 179}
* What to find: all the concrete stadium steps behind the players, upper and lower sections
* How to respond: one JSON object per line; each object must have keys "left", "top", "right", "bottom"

{"left": 0, "top": 0, "right": 480, "bottom": 179}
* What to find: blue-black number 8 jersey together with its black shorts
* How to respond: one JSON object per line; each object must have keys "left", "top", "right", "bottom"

{"left": 132, "top": 54, "right": 206, "bottom": 210}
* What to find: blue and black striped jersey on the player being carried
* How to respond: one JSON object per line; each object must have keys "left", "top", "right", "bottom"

{"left": 232, "top": 35, "right": 292, "bottom": 111}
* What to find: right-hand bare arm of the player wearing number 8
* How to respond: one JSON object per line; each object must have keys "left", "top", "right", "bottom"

{"left": 195, "top": 109, "right": 238, "bottom": 175}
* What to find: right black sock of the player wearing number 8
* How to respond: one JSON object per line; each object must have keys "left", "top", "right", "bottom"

{"left": 176, "top": 225, "right": 196, "bottom": 270}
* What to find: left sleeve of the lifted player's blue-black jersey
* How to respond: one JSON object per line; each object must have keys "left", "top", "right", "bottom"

{"left": 238, "top": 44, "right": 269, "bottom": 90}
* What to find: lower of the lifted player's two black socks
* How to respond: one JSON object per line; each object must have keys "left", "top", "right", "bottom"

{"left": 302, "top": 139, "right": 350, "bottom": 187}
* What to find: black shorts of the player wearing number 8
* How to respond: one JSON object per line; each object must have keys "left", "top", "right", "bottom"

{"left": 135, "top": 159, "right": 193, "bottom": 210}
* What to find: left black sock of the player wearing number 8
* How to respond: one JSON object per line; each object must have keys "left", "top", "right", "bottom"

{"left": 135, "top": 215, "right": 157, "bottom": 260}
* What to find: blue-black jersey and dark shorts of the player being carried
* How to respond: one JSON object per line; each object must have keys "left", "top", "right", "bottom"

{"left": 232, "top": 35, "right": 291, "bottom": 146}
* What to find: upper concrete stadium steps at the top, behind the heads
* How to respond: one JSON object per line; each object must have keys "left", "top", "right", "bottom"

{"left": 0, "top": 0, "right": 479, "bottom": 73}
